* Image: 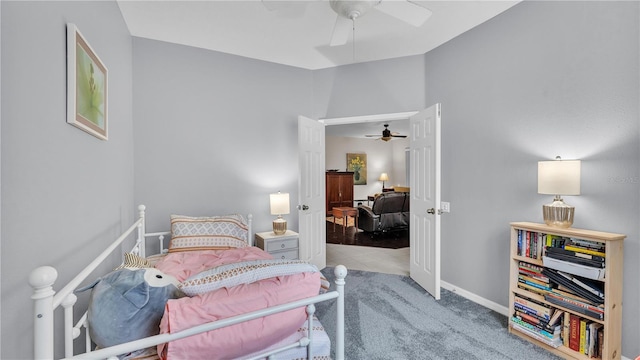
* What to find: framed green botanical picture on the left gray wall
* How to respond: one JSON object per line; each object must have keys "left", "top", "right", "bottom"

{"left": 67, "top": 24, "right": 107, "bottom": 140}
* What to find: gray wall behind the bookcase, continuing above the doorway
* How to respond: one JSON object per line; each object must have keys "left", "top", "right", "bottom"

{"left": 314, "top": 2, "right": 640, "bottom": 357}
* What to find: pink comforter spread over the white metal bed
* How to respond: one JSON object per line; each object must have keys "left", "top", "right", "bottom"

{"left": 156, "top": 247, "right": 320, "bottom": 359}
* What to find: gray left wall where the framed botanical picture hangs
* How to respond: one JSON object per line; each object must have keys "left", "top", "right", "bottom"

{"left": 0, "top": 1, "right": 135, "bottom": 359}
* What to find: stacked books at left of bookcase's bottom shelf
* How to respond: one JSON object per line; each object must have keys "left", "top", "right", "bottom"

{"left": 510, "top": 295, "right": 563, "bottom": 348}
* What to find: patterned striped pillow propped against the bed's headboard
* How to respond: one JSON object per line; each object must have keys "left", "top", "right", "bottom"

{"left": 169, "top": 214, "right": 249, "bottom": 252}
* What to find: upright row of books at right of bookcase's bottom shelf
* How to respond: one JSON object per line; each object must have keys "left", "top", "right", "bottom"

{"left": 562, "top": 312, "right": 604, "bottom": 358}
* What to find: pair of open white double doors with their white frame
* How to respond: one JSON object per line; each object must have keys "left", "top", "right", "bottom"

{"left": 298, "top": 104, "right": 441, "bottom": 300}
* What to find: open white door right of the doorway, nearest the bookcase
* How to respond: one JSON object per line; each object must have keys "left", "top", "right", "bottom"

{"left": 409, "top": 104, "right": 441, "bottom": 300}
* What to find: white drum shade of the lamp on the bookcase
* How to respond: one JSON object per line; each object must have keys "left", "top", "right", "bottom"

{"left": 538, "top": 160, "right": 580, "bottom": 195}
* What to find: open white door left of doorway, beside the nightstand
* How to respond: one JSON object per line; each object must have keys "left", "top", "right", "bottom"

{"left": 298, "top": 116, "right": 327, "bottom": 269}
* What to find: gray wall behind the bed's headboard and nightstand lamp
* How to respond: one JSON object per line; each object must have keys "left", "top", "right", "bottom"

{"left": 134, "top": 38, "right": 312, "bottom": 239}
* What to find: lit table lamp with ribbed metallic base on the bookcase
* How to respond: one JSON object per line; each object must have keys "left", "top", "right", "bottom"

{"left": 538, "top": 156, "right": 580, "bottom": 228}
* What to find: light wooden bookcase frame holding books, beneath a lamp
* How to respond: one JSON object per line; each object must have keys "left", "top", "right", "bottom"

{"left": 509, "top": 222, "right": 626, "bottom": 360}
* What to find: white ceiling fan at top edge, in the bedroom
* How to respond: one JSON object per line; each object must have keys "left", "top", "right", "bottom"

{"left": 329, "top": 0, "right": 431, "bottom": 46}
